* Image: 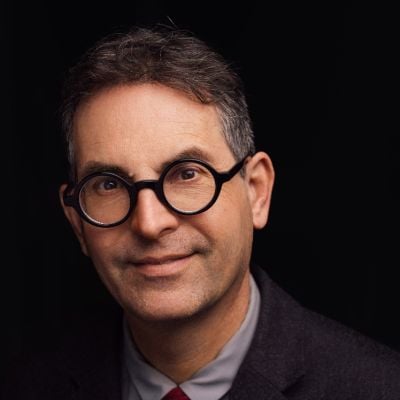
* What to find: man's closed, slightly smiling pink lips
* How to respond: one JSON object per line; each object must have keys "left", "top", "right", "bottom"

{"left": 133, "top": 254, "right": 193, "bottom": 278}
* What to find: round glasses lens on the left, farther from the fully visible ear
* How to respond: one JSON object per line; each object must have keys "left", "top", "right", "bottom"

{"left": 79, "top": 175, "right": 130, "bottom": 225}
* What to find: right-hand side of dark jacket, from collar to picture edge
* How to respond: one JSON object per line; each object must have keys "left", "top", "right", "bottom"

{"left": 247, "top": 268, "right": 400, "bottom": 400}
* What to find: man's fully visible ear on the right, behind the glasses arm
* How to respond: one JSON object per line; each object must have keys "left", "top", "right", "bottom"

{"left": 246, "top": 151, "right": 275, "bottom": 229}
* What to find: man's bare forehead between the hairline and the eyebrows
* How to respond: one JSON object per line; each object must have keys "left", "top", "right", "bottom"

{"left": 74, "top": 84, "right": 233, "bottom": 174}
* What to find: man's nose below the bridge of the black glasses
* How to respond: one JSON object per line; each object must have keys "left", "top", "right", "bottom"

{"left": 130, "top": 188, "right": 179, "bottom": 240}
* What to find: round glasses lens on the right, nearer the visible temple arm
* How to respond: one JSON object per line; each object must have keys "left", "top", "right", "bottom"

{"left": 163, "top": 161, "right": 215, "bottom": 212}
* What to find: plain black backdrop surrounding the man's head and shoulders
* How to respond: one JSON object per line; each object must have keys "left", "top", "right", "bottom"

{"left": 0, "top": 0, "right": 400, "bottom": 372}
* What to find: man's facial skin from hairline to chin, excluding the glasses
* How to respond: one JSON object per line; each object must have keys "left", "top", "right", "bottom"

{"left": 61, "top": 84, "right": 268, "bottom": 320}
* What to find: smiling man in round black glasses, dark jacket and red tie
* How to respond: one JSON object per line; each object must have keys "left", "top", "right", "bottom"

{"left": 6, "top": 28, "right": 400, "bottom": 400}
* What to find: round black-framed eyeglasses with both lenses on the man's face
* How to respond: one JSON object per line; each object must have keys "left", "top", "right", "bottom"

{"left": 63, "top": 156, "right": 248, "bottom": 228}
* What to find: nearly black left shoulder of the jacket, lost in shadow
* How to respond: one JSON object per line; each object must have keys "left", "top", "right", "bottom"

{"left": 0, "top": 305, "right": 122, "bottom": 400}
